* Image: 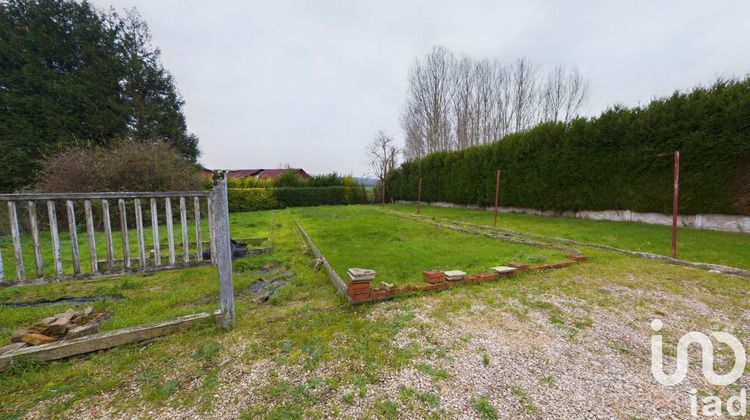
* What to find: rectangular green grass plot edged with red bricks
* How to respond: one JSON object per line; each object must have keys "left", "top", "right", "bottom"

{"left": 294, "top": 206, "right": 565, "bottom": 286}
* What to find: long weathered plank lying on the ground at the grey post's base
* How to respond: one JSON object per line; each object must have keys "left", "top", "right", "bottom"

{"left": 0, "top": 312, "right": 216, "bottom": 369}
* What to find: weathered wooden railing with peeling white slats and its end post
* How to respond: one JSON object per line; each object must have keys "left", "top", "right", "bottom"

{"left": 0, "top": 173, "right": 234, "bottom": 326}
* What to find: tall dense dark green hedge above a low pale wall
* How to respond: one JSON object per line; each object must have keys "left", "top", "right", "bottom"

{"left": 388, "top": 78, "right": 750, "bottom": 215}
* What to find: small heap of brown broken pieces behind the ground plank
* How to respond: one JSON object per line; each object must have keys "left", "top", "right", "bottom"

{"left": 0, "top": 306, "right": 112, "bottom": 353}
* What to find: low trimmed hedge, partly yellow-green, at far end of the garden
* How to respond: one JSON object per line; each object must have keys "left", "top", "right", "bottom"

{"left": 227, "top": 187, "right": 367, "bottom": 213}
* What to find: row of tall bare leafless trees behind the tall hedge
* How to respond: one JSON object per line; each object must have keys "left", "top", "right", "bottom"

{"left": 401, "top": 46, "right": 589, "bottom": 160}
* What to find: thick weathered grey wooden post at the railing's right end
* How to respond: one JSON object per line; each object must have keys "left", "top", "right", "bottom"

{"left": 211, "top": 171, "right": 234, "bottom": 328}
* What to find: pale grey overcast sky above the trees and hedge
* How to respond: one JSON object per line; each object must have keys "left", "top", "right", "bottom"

{"left": 92, "top": 0, "right": 750, "bottom": 176}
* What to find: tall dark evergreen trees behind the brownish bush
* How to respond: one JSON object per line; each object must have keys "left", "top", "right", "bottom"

{"left": 0, "top": 0, "right": 199, "bottom": 192}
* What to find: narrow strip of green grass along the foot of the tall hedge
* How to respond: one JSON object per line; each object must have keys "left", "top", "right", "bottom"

{"left": 389, "top": 205, "right": 750, "bottom": 269}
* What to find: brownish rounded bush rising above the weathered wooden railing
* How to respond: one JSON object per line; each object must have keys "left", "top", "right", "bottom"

{"left": 35, "top": 141, "right": 201, "bottom": 193}
